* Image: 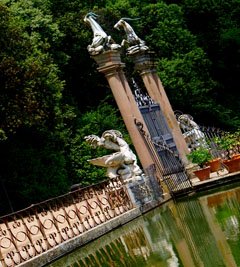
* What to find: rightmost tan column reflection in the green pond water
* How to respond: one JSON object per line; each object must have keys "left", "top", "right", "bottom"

{"left": 199, "top": 197, "right": 237, "bottom": 267}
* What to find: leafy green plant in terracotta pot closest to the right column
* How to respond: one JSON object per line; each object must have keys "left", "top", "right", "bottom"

{"left": 187, "top": 147, "right": 212, "bottom": 181}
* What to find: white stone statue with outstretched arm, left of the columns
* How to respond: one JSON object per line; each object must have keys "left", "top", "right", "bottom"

{"left": 85, "top": 130, "right": 142, "bottom": 180}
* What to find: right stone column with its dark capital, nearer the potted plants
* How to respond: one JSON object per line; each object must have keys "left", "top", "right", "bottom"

{"left": 131, "top": 52, "right": 189, "bottom": 165}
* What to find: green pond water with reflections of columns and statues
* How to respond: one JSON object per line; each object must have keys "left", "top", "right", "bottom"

{"left": 48, "top": 183, "right": 240, "bottom": 267}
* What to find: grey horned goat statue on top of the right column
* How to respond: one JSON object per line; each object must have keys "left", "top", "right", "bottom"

{"left": 114, "top": 18, "right": 149, "bottom": 54}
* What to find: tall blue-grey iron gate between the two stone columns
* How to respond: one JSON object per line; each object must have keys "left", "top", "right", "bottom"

{"left": 133, "top": 81, "right": 192, "bottom": 197}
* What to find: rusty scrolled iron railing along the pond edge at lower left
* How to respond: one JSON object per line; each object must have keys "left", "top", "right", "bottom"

{"left": 0, "top": 177, "right": 133, "bottom": 267}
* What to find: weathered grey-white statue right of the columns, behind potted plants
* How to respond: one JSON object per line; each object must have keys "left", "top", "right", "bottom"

{"left": 178, "top": 114, "right": 208, "bottom": 149}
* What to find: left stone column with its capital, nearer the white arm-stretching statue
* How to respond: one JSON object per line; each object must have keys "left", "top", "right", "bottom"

{"left": 92, "top": 51, "right": 154, "bottom": 172}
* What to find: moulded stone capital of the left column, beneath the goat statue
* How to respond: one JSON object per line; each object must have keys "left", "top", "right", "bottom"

{"left": 92, "top": 50, "right": 125, "bottom": 76}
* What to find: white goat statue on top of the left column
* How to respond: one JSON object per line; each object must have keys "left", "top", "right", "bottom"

{"left": 84, "top": 12, "right": 120, "bottom": 55}
